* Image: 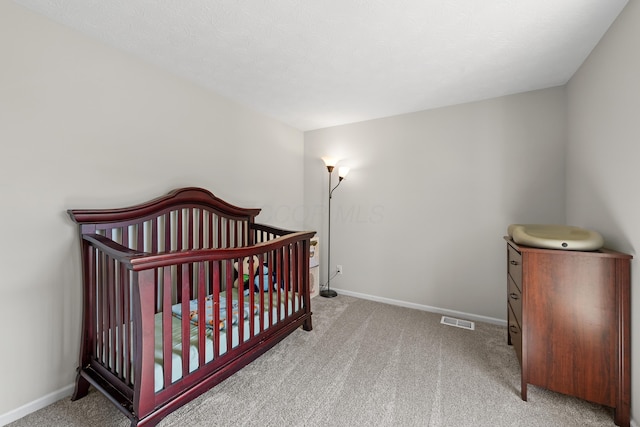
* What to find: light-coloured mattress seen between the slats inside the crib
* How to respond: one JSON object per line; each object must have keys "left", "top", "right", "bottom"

{"left": 154, "top": 289, "right": 299, "bottom": 392}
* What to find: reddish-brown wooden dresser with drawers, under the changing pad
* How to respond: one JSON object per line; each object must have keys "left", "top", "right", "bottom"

{"left": 505, "top": 237, "right": 632, "bottom": 426}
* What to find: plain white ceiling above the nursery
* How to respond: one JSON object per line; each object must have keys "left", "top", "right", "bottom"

{"left": 14, "top": 0, "right": 627, "bottom": 130}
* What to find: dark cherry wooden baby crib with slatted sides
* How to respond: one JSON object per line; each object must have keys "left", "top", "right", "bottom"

{"left": 69, "top": 188, "right": 314, "bottom": 426}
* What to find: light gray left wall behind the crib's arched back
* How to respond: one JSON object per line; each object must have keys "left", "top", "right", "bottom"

{"left": 0, "top": 1, "right": 304, "bottom": 424}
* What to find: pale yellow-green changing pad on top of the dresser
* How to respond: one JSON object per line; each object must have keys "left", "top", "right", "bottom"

{"left": 507, "top": 224, "right": 604, "bottom": 251}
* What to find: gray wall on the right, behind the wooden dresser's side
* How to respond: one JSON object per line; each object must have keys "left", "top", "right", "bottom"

{"left": 566, "top": 1, "right": 640, "bottom": 426}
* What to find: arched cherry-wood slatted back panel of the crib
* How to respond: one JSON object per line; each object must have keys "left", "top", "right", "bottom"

{"left": 68, "top": 187, "right": 260, "bottom": 253}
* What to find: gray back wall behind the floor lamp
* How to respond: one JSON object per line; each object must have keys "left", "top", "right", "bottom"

{"left": 304, "top": 87, "right": 566, "bottom": 321}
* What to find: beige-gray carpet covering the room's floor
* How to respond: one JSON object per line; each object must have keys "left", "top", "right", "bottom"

{"left": 10, "top": 295, "right": 614, "bottom": 427}
